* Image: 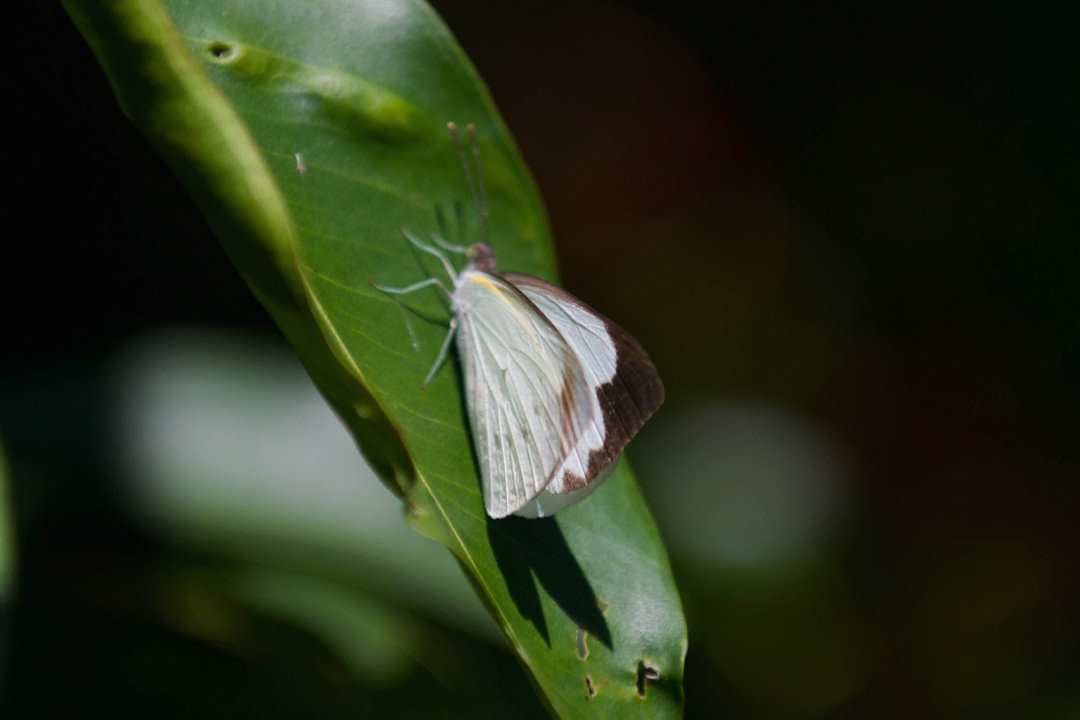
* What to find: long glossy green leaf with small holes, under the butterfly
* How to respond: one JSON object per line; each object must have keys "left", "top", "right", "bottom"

{"left": 65, "top": 0, "right": 686, "bottom": 717}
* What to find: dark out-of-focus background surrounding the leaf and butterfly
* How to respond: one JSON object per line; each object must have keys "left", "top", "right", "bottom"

{"left": 6, "top": 2, "right": 1080, "bottom": 718}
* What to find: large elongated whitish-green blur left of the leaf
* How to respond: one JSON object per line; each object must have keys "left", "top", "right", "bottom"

{"left": 112, "top": 328, "right": 499, "bottom": 639}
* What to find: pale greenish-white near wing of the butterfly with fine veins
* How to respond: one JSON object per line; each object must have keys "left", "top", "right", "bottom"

{"left": 454, "top": 270, "right": 595, "bottom": 518}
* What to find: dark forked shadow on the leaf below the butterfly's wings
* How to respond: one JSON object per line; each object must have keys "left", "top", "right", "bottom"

{"left": 487, "top": 517, "right": 611, "bottom": 649}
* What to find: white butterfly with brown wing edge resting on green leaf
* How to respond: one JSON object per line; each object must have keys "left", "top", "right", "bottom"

{"left": 376, "top": 125, "right": 664, "bottom": 518}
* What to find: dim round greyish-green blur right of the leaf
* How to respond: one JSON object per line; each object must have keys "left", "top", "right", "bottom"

{"left": 635, "top": 398, "right": 856, "bottom": 568}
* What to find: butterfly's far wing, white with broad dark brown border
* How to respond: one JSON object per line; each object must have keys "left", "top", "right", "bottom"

{"left": 503, "top": 273, "right": 664, "bottom": 505}
